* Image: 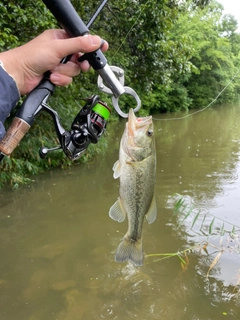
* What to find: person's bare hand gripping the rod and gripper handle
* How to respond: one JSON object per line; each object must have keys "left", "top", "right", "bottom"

{"left": 0, "top": 29, "right": 108, "bottom": 95}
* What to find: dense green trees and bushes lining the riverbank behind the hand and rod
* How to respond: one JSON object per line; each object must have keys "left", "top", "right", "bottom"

{"left": 0, "top": 0, "right": 240, "bottom": 186}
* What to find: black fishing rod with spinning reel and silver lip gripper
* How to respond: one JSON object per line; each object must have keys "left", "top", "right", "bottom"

{"left": 0, "top": 0, "right": 141, "bottom": 162}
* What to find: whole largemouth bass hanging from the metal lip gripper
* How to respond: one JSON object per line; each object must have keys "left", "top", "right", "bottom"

{"left": 109, "top": 109, "right": 157, "bottom": 266}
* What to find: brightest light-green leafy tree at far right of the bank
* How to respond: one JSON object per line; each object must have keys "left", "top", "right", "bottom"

{"left": 173, "top": 1, "right": 240, "bottom": 108}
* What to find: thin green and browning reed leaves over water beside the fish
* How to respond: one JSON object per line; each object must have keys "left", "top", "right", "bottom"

{"left": 145, "top": 194, "right": 240, "bottom": 295}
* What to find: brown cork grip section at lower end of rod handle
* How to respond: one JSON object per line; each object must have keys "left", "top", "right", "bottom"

{"left": 0, "top": 117, "right": 30, "bottom": 156}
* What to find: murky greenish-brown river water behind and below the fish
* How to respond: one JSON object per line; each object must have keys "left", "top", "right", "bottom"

{"left": 0, "top": 105, "right": 240, "bottom": 320}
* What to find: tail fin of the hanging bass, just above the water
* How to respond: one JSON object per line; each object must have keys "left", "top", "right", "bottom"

{"left": 115, "top": 237, "right": 143, "bottom": 266}
